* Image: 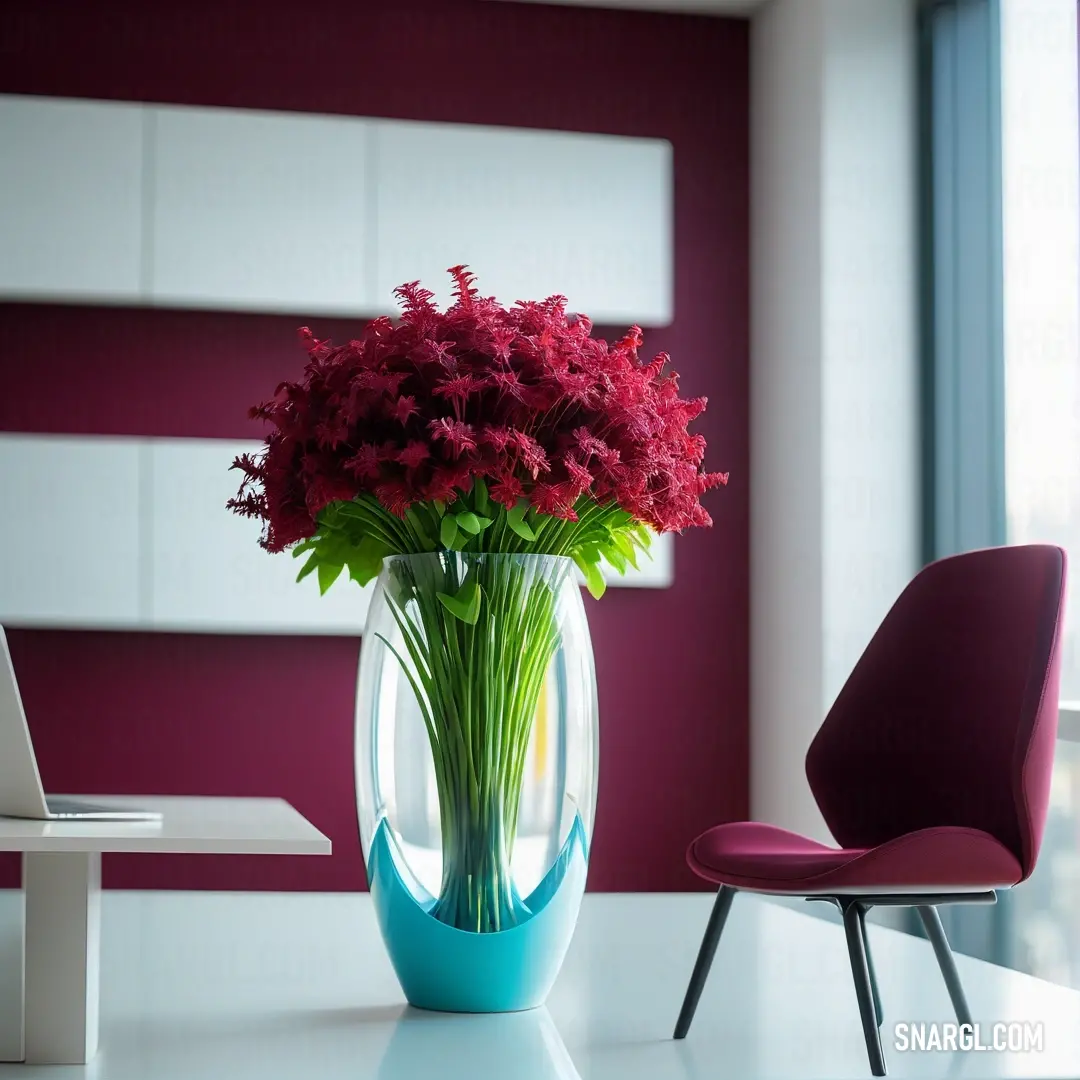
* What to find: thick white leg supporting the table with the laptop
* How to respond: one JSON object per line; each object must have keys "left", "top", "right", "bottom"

{"left": 23, "top": 851, "right": 102, "bottom": 1065}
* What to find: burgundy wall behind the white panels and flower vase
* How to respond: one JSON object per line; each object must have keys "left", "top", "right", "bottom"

{"left": 0, "top": 0, "right": 750, "bottom": 890}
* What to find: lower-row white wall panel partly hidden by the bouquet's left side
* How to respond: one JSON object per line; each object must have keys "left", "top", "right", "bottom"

{"left": 147, "top": 438, "right": 374, "bottom": 635}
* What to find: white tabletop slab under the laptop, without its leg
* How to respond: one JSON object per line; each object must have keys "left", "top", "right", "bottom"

{"left": 0, "top": 795, "right": 330, "bottom": 855}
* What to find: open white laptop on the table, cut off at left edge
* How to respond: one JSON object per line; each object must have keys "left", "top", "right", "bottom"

{"left": 0, "top": 626, "right": 161, "bottom": 821}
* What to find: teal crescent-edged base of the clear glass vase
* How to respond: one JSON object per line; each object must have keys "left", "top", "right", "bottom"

{"left": 367, "top": 818, "right": 586, "bottom": 1013}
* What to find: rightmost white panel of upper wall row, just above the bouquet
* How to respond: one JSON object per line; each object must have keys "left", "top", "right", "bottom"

{"left": 376, "top": 121, "right": 673, "bottom": 326}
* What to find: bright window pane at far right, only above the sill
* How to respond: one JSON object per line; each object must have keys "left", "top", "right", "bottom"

{"left": 1001, "top": 0, "right": 1080, "bottom": 700}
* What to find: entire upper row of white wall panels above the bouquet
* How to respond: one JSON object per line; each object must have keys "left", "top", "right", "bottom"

{"left": 0, "top": 95, "right": 674, "bottom": 326}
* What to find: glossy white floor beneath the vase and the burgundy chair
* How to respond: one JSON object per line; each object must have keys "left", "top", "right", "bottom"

{"left": 0, "top": 892, "right": 1080, "bottom": 1080}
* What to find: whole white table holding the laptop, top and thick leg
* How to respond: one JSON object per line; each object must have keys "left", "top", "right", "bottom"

{"left": 0, "top": 795, "right": 330, "bottom": 1064}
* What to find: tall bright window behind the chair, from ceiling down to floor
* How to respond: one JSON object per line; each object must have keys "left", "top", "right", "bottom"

{"left": 1000, "top": 0, "right": 1080, "bottom": 987}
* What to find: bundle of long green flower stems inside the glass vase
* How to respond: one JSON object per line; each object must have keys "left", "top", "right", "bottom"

{"left": 390, "top": 556, "right": 569, "bottom": 933}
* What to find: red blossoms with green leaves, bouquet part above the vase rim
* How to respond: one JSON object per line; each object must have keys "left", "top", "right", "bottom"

{"left": 229, "top": 267, "right": 728, "bottom": 595}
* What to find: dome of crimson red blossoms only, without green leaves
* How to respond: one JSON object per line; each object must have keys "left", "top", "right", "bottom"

{"left": 229, "top": 267, "right": 728, "bottom": 551}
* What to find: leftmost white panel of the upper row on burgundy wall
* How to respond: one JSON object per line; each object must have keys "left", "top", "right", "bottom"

{"left": 0, "top": 95, "right": 143, "bottom": 301}
